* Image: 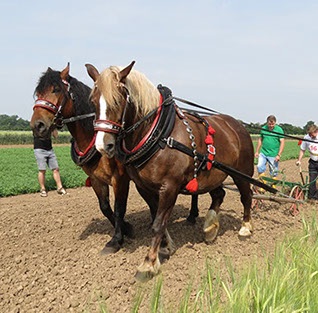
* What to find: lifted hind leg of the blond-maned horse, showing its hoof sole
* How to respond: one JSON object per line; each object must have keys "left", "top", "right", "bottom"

{"left": 203, "top": 186, "right": 225, "bottom": 243}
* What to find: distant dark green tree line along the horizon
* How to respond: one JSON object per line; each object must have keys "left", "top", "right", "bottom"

{"left": 0, "top": 114, "right": 314, "bottom": 135}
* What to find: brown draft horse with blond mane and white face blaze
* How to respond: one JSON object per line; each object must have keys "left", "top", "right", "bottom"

{"left": 86, "top": 62, "right": 254, "bottom": 279}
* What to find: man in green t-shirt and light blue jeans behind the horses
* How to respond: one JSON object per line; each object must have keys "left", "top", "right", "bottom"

{"left": 255, "top": 115, "right": 285, "bottom": 179}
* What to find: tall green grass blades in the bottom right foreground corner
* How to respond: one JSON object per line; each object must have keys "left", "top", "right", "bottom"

{"left": 128, "top": 211, "right": 318, "bottom": 313}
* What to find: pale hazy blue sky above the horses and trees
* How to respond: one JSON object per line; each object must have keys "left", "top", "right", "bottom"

{"left": 0, "top": 0, "right": 318, "bottom": 127}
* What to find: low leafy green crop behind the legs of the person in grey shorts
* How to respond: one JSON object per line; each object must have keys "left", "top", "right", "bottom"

{"left": 0, "top": 147, "right": 87, "bottom": 197}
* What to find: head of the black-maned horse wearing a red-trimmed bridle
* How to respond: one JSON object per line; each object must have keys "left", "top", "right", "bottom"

{"left": 30, "top": 64, "right": 73, "bottom": 138}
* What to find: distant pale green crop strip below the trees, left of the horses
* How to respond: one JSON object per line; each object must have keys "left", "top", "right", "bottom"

{"left": 0, "top": 130, "right": 72, "bottom": 145}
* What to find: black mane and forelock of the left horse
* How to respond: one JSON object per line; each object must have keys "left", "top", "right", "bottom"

{"left": 34, "top": 68, "right": 96, "bottom": 133}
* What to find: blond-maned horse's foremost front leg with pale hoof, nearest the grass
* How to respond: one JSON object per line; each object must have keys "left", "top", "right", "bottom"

{"left": 136, "top": 186, "right": 178, "bottom": 281}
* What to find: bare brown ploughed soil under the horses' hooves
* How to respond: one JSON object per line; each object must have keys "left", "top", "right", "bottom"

{"left": 0, "top": 160, "right": 314, "bottom": 313}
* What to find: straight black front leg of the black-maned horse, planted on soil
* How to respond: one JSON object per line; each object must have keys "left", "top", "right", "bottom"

{"left": 101, "top": 176, "right": 133, "bottom": 255}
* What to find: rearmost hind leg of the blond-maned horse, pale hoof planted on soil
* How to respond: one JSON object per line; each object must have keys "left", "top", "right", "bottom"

{"left": 233, "top": 177, "right": 254, "bottom": 238}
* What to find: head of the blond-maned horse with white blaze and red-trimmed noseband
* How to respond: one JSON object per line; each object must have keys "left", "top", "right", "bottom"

{"left": 85, "top": 61, "right": 135, "bottom": 158}
